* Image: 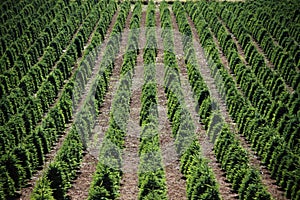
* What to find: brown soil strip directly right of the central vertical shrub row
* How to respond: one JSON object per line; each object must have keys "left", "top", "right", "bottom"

{"left": 156, "top": 12, "right": 187, "bottom": 200}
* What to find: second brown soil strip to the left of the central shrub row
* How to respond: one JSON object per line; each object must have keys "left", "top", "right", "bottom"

{"left": 68, "top": 12, "right": 132, "bottom": 200}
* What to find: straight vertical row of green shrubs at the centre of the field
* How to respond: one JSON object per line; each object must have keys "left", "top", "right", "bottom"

{"left": 138, "top": 1, "right": 167, "bottom": 199}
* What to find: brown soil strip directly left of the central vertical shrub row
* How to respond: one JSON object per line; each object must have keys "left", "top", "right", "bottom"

{"left": 120, "top": 11, "right": 146, "bottom": 200}
